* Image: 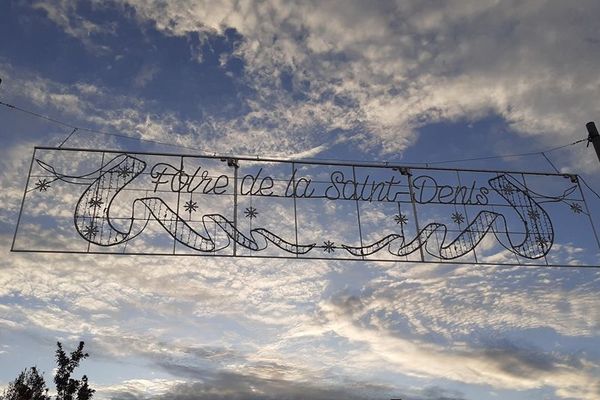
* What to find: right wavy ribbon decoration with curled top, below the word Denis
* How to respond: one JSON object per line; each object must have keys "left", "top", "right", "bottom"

{"left": 342, "top": 175, "right": 554, "bottom": 260}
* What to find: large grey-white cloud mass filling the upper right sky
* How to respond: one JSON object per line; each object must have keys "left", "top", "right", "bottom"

{"left": 45, "top": 0, "right": 598, "bottom": 166}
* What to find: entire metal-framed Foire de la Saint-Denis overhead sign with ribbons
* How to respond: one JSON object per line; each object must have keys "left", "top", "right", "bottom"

{"left": 12, "top": 147, "right": 599, "bottom": 265}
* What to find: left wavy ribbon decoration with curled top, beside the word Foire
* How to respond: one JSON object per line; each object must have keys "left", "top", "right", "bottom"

{"left": 63, "top": 154, "right": 316, "bottom": 254}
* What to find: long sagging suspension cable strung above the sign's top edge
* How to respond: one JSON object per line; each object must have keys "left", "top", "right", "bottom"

{"left": 0, "top": 101, "right": 588, "bottom": 168}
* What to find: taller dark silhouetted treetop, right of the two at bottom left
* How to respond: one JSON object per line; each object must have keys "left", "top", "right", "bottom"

{"left": 54, "top": 342, "right": 94, "bottom": 400}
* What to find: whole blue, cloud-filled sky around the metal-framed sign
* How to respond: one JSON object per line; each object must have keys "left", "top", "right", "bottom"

{"left": 0, "top": 0, "right": 600, "bottom": 400}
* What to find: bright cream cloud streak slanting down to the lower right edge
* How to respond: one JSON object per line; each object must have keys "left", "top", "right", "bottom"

{"left": 304, "top": 286, "right": 599, "bottom": 399}
